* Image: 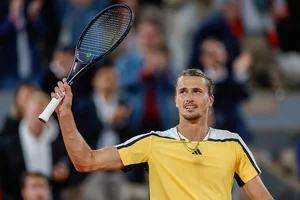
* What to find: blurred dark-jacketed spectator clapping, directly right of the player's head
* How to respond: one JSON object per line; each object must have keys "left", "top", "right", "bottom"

{"left": 199, "top": 38, "right": 251, "bottom": 142}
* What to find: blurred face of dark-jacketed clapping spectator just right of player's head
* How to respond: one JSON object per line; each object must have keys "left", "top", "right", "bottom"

{"left": 200, "top": 39, "right": 228, "bottom": 68}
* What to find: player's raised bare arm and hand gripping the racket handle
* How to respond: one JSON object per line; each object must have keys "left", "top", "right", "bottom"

{"left": 51, "top": 79, "right": 124, "bottom": 172}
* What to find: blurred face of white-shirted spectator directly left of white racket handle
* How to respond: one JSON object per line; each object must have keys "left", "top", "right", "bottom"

{"left": 25, "top": 92, "right": 50, "bottom": 137}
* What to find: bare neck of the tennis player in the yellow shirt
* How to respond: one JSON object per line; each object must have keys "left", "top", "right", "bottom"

{"left": 177, "top": 119, "right": 209, "bottom": 141}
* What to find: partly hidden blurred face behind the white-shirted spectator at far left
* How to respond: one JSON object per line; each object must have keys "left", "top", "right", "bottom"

{"left": 15, "top": 84, "right": 35, "bottom": 118}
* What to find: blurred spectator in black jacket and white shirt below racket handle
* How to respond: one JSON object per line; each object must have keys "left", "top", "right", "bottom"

{"left": 0, "top": 91, "right": 70, "bottom": 200}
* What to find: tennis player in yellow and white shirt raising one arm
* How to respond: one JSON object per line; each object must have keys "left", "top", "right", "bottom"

{"left": 51, "top": 69, "right": 273, "bottom": 200}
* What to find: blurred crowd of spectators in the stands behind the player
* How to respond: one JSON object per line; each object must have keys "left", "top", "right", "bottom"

{"left": 0, "top": 0, "right": 300, "bottom": 200}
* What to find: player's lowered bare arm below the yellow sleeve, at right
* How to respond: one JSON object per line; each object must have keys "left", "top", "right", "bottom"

{"left": 243, "top": 176, "right": 273, "bottom": 200}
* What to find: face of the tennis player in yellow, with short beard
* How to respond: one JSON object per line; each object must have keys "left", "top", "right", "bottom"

{"left": 175, "top": 76, "right": 214, "bottom": 121}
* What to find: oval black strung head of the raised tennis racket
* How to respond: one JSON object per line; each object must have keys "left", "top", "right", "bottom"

{"left": 75, "top": 4, "right": 134, "bottom": 68}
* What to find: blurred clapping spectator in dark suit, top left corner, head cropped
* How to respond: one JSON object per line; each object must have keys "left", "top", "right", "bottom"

{"left": 0, "top": 0, "right": 43, "bottom": 88}
